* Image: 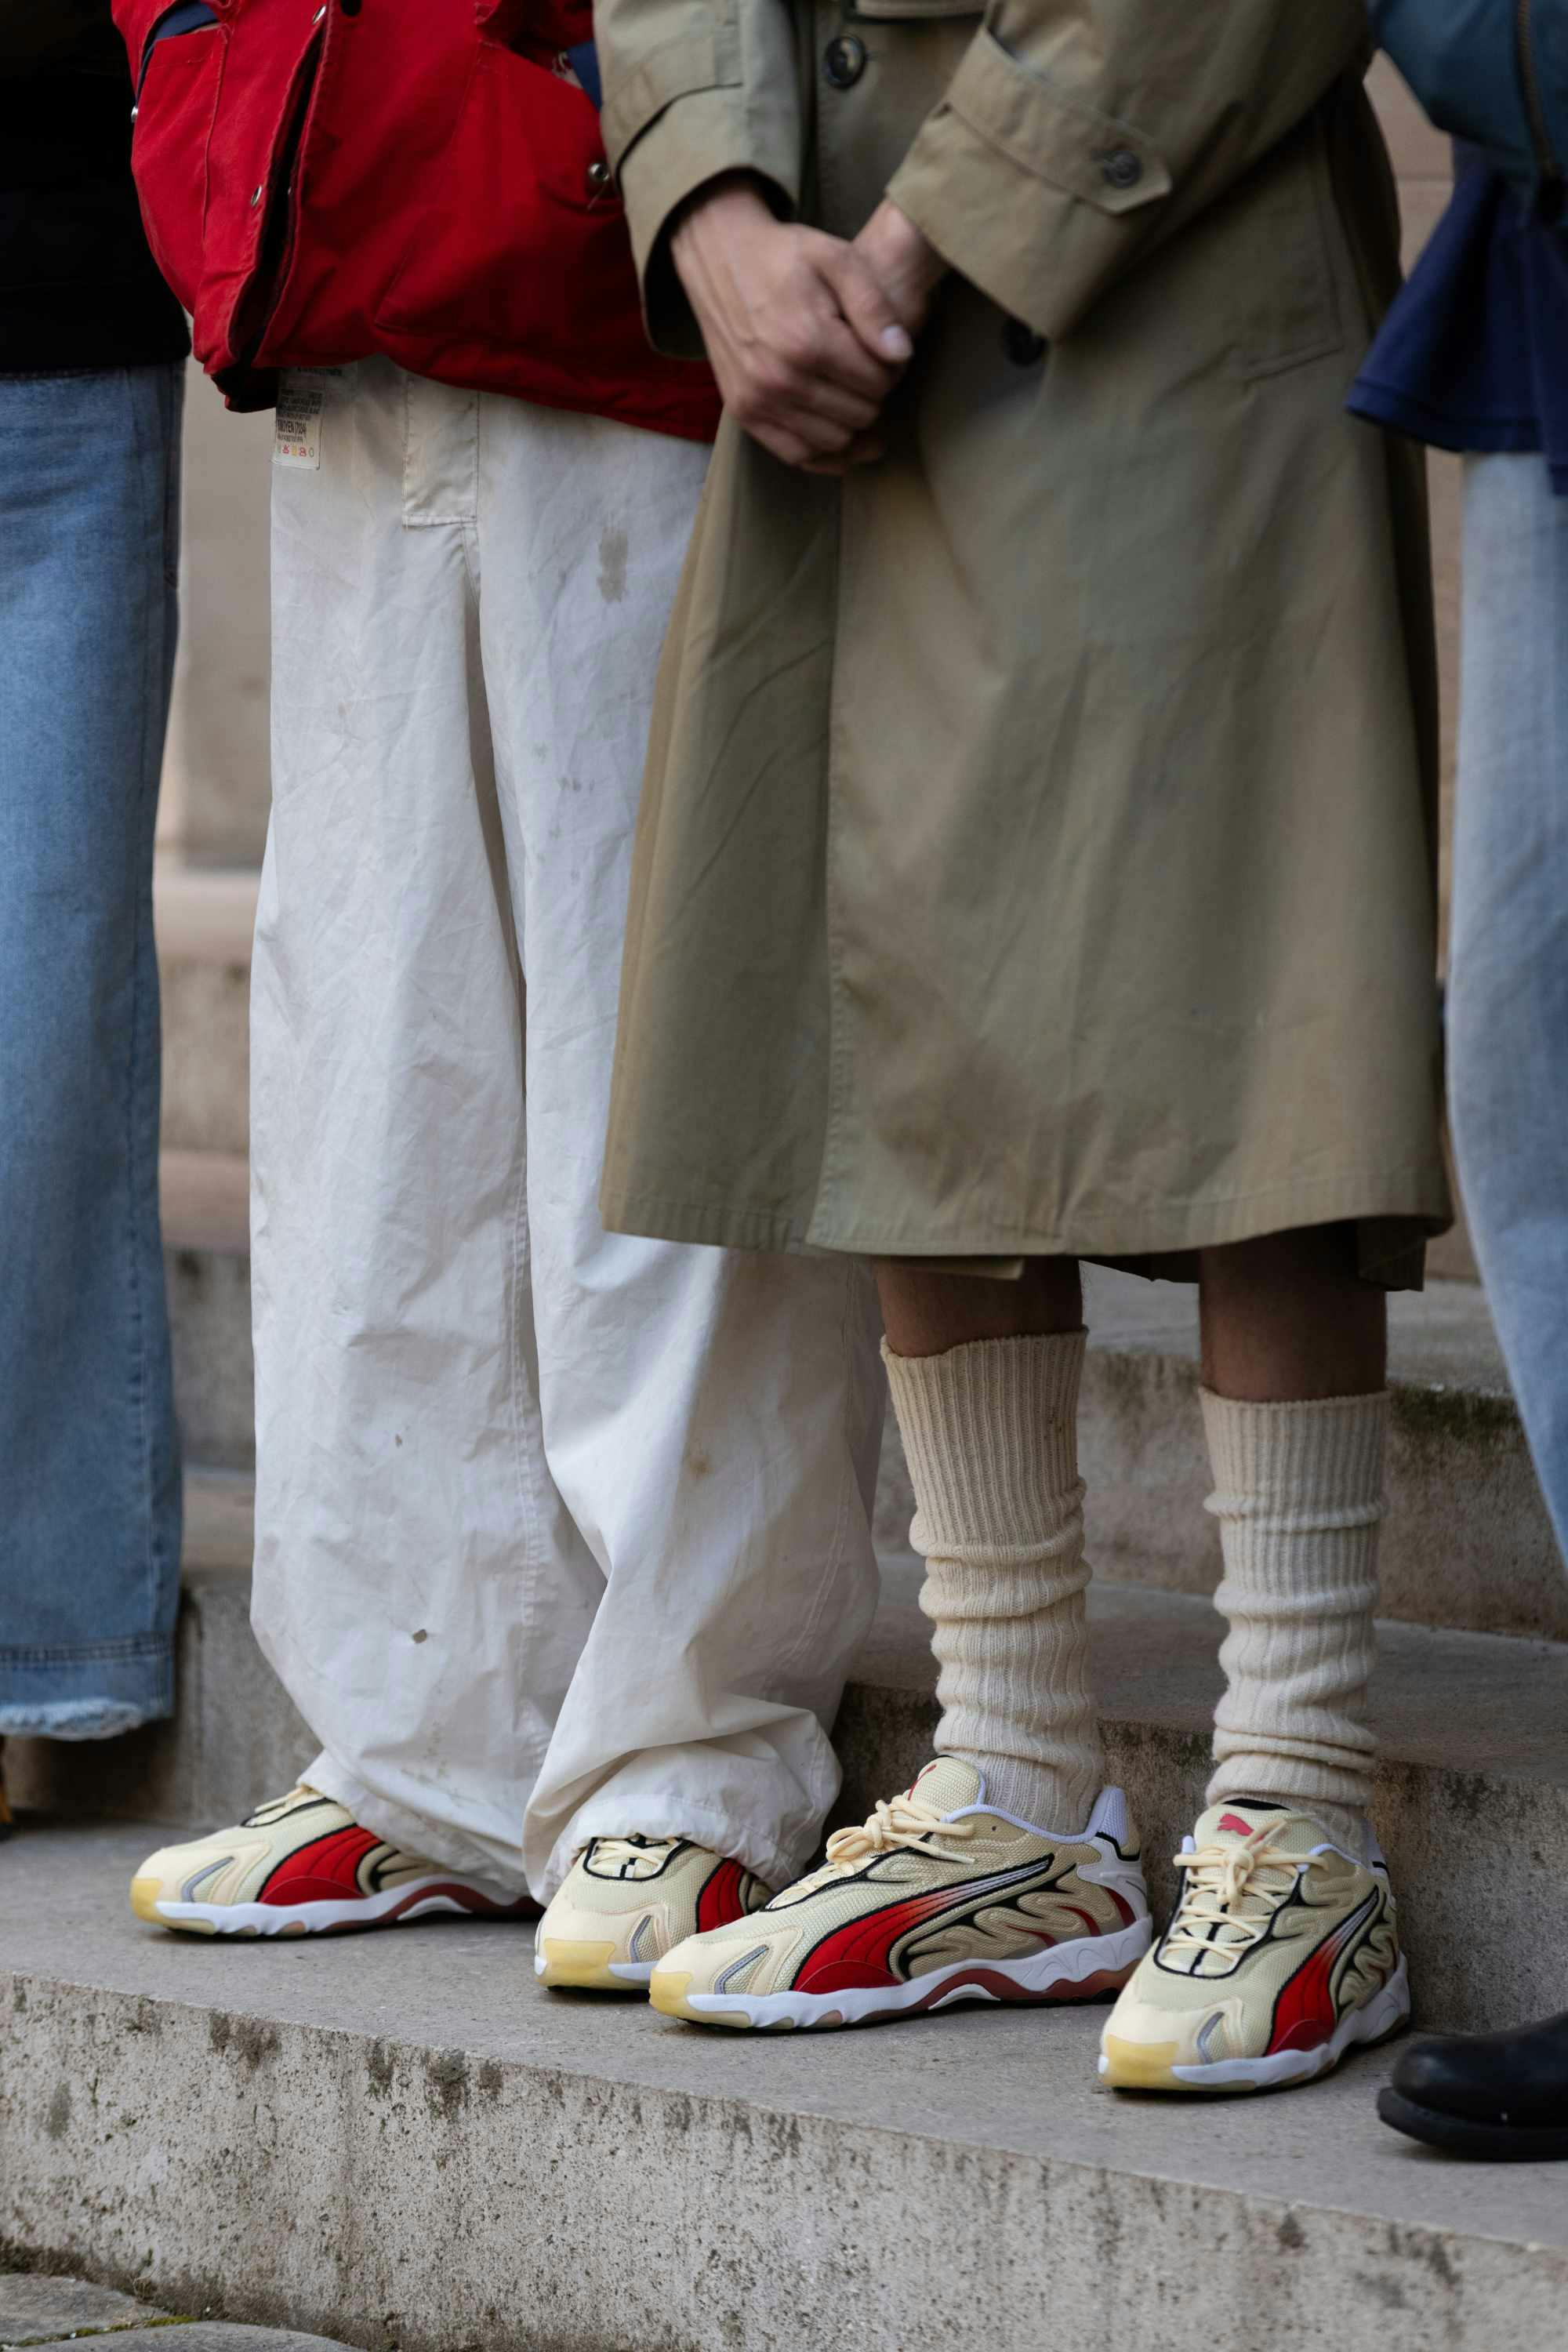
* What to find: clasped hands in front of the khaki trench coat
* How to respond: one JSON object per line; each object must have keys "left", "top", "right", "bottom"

{"left": 670, "top": 174, "right": 945, "bottom": 473}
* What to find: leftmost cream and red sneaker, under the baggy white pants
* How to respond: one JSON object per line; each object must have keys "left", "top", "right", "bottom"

{"left": 132, "top": 1788, "right": 539, "bottom": 1936}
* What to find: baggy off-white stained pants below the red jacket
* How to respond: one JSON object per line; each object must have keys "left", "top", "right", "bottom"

{"left": 252, "top": 360, "right": 881, "bottom": 1900}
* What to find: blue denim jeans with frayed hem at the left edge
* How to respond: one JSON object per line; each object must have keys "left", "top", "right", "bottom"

{"left": 0, "top": 365, "right": 183, "bottom": 1738}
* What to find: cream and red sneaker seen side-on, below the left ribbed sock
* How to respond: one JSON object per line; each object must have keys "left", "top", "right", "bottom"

{"left": 649, "top": 1757, "right": 1149, "bottom": 2027}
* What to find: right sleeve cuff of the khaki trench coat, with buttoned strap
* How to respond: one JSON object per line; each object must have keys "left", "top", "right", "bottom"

{"left": 886, "top": 31, "right": 1173, "bottom": 341}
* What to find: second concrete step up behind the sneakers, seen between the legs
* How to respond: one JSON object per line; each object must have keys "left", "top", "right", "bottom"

{"left": 152, "top": 1152, "right": 1568, "bottom": 1642}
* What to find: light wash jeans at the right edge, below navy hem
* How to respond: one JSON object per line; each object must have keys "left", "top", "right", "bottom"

{"left": 1448, "top": 456, "right": 1568, "bottom": 1552}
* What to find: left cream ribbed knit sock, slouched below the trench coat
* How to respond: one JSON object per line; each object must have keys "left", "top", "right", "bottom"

{"left": 881, "top": 1331, "right": 1105, "bottom": 1830}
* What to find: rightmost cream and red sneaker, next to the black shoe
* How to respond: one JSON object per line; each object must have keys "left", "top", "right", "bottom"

{"left": 1100, "top": 1797, "right": 1410, "bottom": 2091}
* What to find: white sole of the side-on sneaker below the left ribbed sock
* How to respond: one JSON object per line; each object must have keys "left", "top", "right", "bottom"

{"left": 649, "top": 1917, "right": 1152, "bottom": 2032}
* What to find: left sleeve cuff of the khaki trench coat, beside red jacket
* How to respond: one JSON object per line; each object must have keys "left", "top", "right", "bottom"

{"left": 602, "top": 35, "right": 799, "bottom": 360}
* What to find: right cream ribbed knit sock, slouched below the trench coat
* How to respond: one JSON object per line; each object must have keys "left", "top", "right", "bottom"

{"left": 1203, "top": 1390, "right": 1389, "bottom": 1853}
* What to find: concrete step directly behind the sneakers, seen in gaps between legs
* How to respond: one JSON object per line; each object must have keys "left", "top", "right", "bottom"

{"left": 7, "top": 1475, "right": 1568, "bottom": 2027}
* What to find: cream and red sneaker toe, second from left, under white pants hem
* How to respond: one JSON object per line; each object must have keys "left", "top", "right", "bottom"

{"left": 534, "top": 1837, "right": 769, "bottom": 1992}
